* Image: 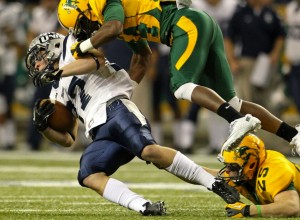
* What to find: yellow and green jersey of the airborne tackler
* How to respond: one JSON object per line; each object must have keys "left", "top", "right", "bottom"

{"left": 89, "top": 0, "right": 162, "bottom": 42}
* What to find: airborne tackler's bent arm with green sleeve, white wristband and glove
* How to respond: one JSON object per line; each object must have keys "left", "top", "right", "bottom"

{"left": 71, "top": 0, "right": 125, "bottom": 59}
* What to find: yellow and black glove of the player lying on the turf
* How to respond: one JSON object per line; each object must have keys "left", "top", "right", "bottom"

{"left": 225, "top": 202, "right": 250, "bottom": 218}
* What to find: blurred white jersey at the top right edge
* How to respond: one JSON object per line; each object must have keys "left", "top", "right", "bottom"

{"left": 285, "top": 1, "right": 300, "bottom": 64}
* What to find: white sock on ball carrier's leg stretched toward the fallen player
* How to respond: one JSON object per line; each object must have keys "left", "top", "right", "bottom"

{"left": 166, "top": 151, "right": 215, "bottom": 189}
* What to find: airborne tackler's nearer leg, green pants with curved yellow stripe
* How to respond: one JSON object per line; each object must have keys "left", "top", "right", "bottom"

{"left": 170, "top": 9, "right": 260, "bottom": 150}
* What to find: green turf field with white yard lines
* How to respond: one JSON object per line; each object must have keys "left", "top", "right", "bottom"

{"left": 0, "top": 151, "right": 300, "bottom": 220}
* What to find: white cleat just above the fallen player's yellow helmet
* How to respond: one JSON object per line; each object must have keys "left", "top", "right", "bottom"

{"left": 222, "top": 114, "right": 262, "bottom": 151}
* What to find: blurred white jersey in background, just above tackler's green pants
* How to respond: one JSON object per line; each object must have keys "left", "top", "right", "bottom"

{"left": 191, "top": 0, "right": 239, "bottom": 31}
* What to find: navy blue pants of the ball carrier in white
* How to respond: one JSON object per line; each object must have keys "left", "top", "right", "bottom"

{"left": 78, "top": 100, "right": 155, "bottom": 186}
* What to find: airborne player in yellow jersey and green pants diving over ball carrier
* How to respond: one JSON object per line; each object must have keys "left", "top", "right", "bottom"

{"left": 51, "top": 0, "right": 300, "bottom": 154}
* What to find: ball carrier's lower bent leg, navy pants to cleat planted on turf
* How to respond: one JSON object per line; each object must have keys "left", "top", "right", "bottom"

{"left": 78, "top": 140, "right": 165, "bottom": 215}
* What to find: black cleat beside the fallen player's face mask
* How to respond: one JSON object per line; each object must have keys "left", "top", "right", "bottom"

{"left": 211, "top": 178, "right": 240, "bottom": 204}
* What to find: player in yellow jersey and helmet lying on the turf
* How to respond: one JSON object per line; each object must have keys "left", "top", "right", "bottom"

{"left": 218, "top": 134, "right": 300, "bottom": 218}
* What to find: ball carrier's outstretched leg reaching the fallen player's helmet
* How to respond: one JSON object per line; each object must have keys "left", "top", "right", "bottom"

{"left": 102, "top": 99, "right": 239, "bottom": 203}
